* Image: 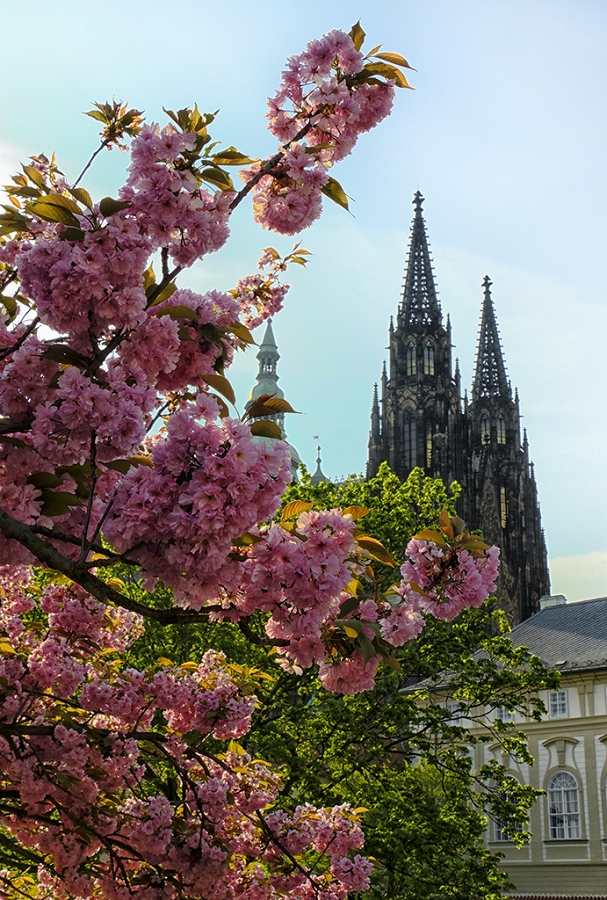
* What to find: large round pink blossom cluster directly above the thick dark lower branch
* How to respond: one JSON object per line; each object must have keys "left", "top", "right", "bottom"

{"left": 105, "top": 394, "right": 290, "bottom": 609}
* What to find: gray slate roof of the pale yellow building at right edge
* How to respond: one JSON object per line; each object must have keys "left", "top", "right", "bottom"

{"left": 510, "top": 597, "right": 607, "bottom": 672}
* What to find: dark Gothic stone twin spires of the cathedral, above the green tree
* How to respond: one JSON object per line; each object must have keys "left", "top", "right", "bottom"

{"left": 367, "top": 191, "right": 550, "bottom": 625}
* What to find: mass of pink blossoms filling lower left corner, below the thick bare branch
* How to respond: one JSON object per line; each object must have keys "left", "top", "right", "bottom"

{"left": 0, "top": 567, "right": 371, "bottom": 900}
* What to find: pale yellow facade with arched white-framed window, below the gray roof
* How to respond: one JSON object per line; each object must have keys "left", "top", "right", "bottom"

{"left": 475, "top": 668, "right": 607, "bottom": 898}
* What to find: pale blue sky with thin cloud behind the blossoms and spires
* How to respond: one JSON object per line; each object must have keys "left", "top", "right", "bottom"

{"left": 0, "top": 0, "right": 607, "bottom": 599}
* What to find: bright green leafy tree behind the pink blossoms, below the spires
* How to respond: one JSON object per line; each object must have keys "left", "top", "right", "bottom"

{"left": 115, "top": 465, "right": 552, "bottom": 900}
